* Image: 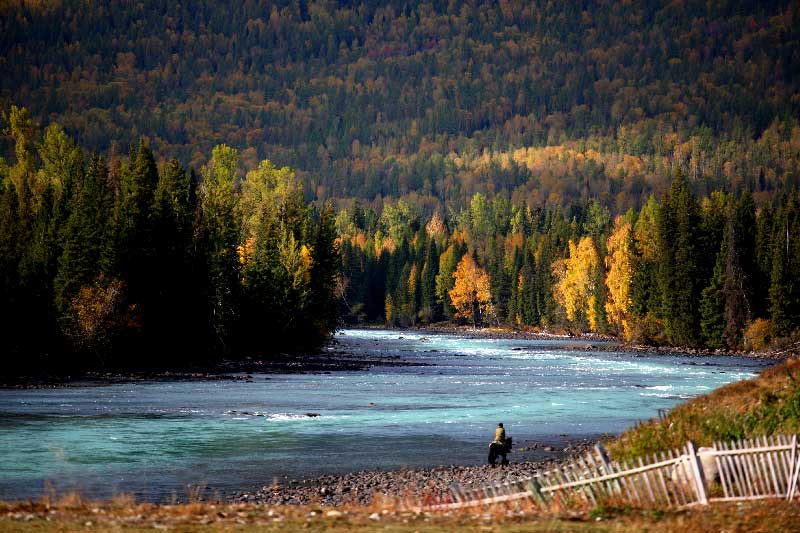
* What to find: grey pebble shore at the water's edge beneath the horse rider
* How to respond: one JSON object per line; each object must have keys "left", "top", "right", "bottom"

{"left": 231, "top": 436, "right": 599, "bottom": 506}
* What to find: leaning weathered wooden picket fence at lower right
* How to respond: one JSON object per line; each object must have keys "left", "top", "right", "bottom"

{"left": 425, "top": 435, "right": 800, "bottom": 511}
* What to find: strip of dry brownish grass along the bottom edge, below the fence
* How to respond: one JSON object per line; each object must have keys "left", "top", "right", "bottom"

{"left": 0, "top": 495, "right": 800, "bottom": 533}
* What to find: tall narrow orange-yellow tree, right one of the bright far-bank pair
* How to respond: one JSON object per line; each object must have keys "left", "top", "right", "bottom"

{"left": 605, "top": 217, "right": 633, "bottom": 341}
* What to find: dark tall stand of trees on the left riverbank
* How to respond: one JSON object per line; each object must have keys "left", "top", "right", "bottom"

{"left": 0, "top": 107, "right": 340, "bottom": 374}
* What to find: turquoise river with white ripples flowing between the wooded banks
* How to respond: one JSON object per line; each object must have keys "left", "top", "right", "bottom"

{"left": 0, "top": 330, "right": 763, "bottom": 501}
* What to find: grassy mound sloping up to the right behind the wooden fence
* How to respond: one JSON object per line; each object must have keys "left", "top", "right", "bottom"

{"left": 608, "top": 359, "right": 800, "bottom": 459}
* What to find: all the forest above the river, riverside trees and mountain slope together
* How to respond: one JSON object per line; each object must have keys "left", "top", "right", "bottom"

{"left": 0, "top": 0, "right": 800, "bottom": 365}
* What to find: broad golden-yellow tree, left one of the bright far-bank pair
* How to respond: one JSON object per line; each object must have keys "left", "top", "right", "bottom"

{"left": 553, "top": 237, "right": 600, "bottom": 330}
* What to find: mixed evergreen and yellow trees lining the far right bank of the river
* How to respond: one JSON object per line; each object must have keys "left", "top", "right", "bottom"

{"left": 337, "top": 183, "right": 800, "bottom": 349}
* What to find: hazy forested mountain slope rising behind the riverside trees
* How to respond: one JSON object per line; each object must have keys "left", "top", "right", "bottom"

{"left": 0, "top": 0, "right": 800, "bottom": 209}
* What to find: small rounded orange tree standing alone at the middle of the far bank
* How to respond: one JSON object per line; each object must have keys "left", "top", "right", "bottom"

{"left": 449, "top": 254, "right": 494, "bottom": 326}
